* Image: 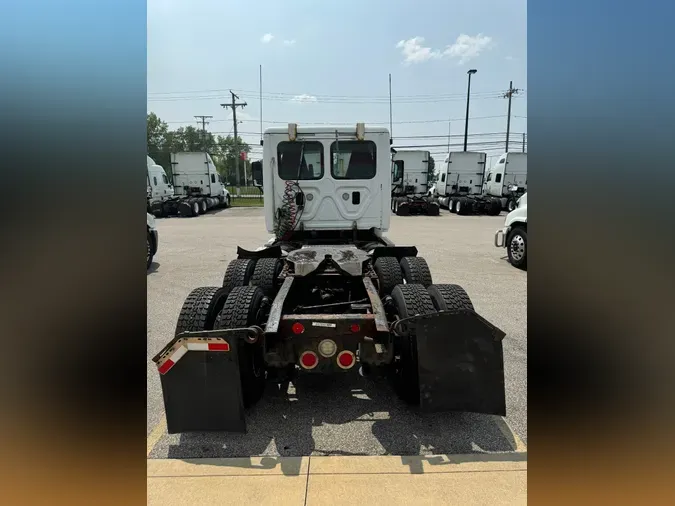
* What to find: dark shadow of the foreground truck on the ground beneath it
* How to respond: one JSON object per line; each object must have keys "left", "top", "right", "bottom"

{"left": 168, "top": 374, "right": 516, "bottom": 474}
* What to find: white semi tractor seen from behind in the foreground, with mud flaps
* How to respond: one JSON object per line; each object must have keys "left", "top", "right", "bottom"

{"left": 153, "top": 123, "right": 506, "bottom": 433}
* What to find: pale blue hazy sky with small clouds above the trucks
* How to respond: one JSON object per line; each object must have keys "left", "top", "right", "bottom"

{"left": 147, "top": 0, "right": 527, "bottom": 163}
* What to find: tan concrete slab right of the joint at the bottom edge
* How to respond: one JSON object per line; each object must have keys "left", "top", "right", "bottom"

{"left": 306, "top": 469, "right": 527, "bottom": 506}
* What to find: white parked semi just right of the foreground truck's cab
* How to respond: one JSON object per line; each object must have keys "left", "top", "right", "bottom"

{"left": 391, "top": 148, "right": 440, "bottom": 216}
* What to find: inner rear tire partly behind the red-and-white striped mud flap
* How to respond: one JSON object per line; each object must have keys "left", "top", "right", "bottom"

{"left": 214, "top": 286, "right": 266, "bottom": 408}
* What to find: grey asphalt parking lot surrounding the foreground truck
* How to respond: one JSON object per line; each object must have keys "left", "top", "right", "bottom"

{"left": 147, "top": 208, "right": 527, "bottom": 458}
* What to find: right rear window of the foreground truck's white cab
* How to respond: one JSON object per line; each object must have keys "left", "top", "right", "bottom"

{"left": 330, "top": 141, "right": 377, "bottom": 179}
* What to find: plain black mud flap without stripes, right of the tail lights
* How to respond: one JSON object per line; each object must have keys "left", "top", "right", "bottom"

{"left": 416, "top": 310, "right": 506, "bottom": 416}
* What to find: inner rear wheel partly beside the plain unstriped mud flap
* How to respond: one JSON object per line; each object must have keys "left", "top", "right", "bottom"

{"left": 391, "top": 285, "right": 436, "bottom": 405}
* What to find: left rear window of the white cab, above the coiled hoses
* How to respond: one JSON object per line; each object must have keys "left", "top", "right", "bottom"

{"left": 277, "top": 141, "right": 324, "bottom": 181}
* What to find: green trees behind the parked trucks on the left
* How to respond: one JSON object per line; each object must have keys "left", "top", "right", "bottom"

{"left": 147, "top": 112, "right": 251, "bottom": 185}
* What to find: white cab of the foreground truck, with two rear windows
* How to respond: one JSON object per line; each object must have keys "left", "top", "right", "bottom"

{"left": 252, "top": 123, "right": 391, "bottom": 235}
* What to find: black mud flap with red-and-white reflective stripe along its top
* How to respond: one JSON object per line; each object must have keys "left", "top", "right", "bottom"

{"left": 153, "top": 329, "right": 252, "bottom": 434}
